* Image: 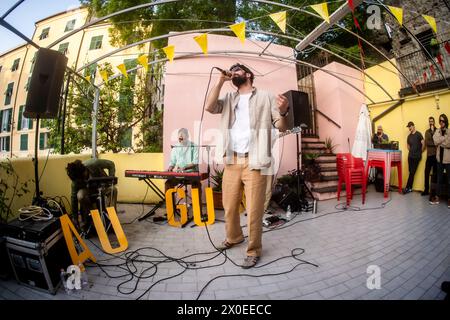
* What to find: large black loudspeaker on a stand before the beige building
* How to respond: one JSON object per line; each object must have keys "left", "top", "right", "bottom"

{"left": 23, "top": 48, "right": 67, "bottom": 119}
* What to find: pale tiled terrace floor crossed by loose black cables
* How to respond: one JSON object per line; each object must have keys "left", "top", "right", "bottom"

{"left": 0, "top": 185, "right": 450, "bottom": 300}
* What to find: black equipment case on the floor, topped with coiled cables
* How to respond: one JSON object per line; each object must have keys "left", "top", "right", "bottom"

{"left": 6, "top": 228, "right": 72, "bottom": 294}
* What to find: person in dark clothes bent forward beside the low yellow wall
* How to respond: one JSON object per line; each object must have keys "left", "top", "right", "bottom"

{"left": 66, "top": 159, "right": 117, "bottom": 232}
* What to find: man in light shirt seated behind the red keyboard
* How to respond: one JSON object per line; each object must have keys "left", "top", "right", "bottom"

{"left": 165, "top": 128, "right": 202, "bottom": 203}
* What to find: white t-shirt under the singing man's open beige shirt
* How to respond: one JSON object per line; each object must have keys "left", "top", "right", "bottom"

{"left": 230, "top": 93, "right": 251, "bottom": 153}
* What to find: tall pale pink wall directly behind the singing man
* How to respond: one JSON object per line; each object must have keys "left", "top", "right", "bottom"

{"left": 163, "top": 34, "right": 297, "bottom": 188}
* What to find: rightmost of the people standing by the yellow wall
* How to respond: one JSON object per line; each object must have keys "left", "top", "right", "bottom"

{"left": 430, "top": 114, "right": 450, "bottom": 208}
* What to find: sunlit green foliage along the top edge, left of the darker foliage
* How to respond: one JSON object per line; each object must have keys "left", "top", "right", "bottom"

{"left": 81, "top": 0, "right": 236, "bottom": 48}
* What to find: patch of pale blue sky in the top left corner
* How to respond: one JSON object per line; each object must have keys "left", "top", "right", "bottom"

{"left": 0, "top": 0, "right": 80, "bottom": 53}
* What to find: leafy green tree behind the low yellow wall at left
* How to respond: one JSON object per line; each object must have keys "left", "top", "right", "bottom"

{"left": 45, "top": 63, "right": 162, "bottom": 153}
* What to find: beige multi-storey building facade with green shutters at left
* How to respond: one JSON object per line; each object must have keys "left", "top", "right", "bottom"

{"left": 0, "top": 8, "right": 149, "bottom": 158}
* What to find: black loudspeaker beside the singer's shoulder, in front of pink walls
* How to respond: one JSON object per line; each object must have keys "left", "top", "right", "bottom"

{"left": 283, "top": 90, "right": 313, "bottom": 129}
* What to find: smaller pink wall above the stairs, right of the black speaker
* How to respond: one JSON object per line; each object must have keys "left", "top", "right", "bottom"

{"left": 314, "top": 62, "right": 365, "bottom": 153}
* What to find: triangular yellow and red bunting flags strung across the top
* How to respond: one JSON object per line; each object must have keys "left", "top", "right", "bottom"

{"left": 85, "top": 0, "right": 450, "bottom": 82}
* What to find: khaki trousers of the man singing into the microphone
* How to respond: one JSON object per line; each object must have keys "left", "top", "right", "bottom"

{"left": 222, "top": 156, "right": 267, "bottom": 257}
